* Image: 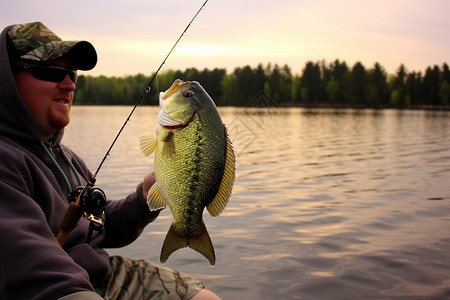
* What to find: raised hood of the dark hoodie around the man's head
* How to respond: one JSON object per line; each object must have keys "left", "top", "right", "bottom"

{"left": 0, "top": 27, "right": 64, "bottom": 143}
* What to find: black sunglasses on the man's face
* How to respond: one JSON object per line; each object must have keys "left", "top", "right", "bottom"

{"left": 14, "top": 64, "right": 78, "bottom": 83}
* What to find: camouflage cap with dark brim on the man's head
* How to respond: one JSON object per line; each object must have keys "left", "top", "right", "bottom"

{"left": 8, "top": 22, "right": 97, "bottom": 70}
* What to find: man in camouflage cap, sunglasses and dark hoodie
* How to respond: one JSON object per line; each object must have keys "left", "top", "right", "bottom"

{"left": 0, "top": 22, "right": 218, "bottom": 300}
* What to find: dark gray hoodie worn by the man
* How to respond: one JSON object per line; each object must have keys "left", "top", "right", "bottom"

{"left": 0, "top": 25, "right": 158, "bottom": 300}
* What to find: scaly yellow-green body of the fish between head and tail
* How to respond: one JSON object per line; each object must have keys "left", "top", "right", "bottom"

{"left": 155, "top": 115, "right": 226, "bottom": 235}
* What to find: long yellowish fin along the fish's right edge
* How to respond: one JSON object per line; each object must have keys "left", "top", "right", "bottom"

{"left": 206, "top": 126, "right": 236, "bottom": 217}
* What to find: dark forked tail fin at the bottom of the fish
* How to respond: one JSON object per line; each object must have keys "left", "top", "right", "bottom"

{"left": 160, "top": 223, "right": 216, "bottom": 266}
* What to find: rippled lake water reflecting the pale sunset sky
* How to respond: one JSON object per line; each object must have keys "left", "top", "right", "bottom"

{"left": 63, "top": 107, "right": 450, "bottom": 299}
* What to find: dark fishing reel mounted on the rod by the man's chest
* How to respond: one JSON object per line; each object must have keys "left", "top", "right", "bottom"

{"left": 69, "top": 185, "right": 106, "bottom": 244}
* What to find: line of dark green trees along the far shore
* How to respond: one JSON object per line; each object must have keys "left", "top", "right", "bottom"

{"left": 75, "top": 59, "right": 450, "bottom": 109}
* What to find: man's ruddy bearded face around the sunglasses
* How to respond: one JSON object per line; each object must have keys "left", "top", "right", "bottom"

{"left": 14, "top": 57, "right": 75, "bottom": 138}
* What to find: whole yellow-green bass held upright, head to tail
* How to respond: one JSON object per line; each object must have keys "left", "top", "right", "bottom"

{"left": 140, "top": 79, "right": 236, "bottom": 265}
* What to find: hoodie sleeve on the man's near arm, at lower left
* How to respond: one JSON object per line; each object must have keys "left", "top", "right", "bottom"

{"left": 0, "top": 159, "right": 93, "bottom": 299}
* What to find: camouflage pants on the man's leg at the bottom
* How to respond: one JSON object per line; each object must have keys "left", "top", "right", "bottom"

{"left": 95, "top": 256, "right": 205, "bottom": 300}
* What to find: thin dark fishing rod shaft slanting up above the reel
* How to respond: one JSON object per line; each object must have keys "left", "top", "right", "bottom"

{"left": 90, "top": 0, "right": 208, "bottom": 184}
